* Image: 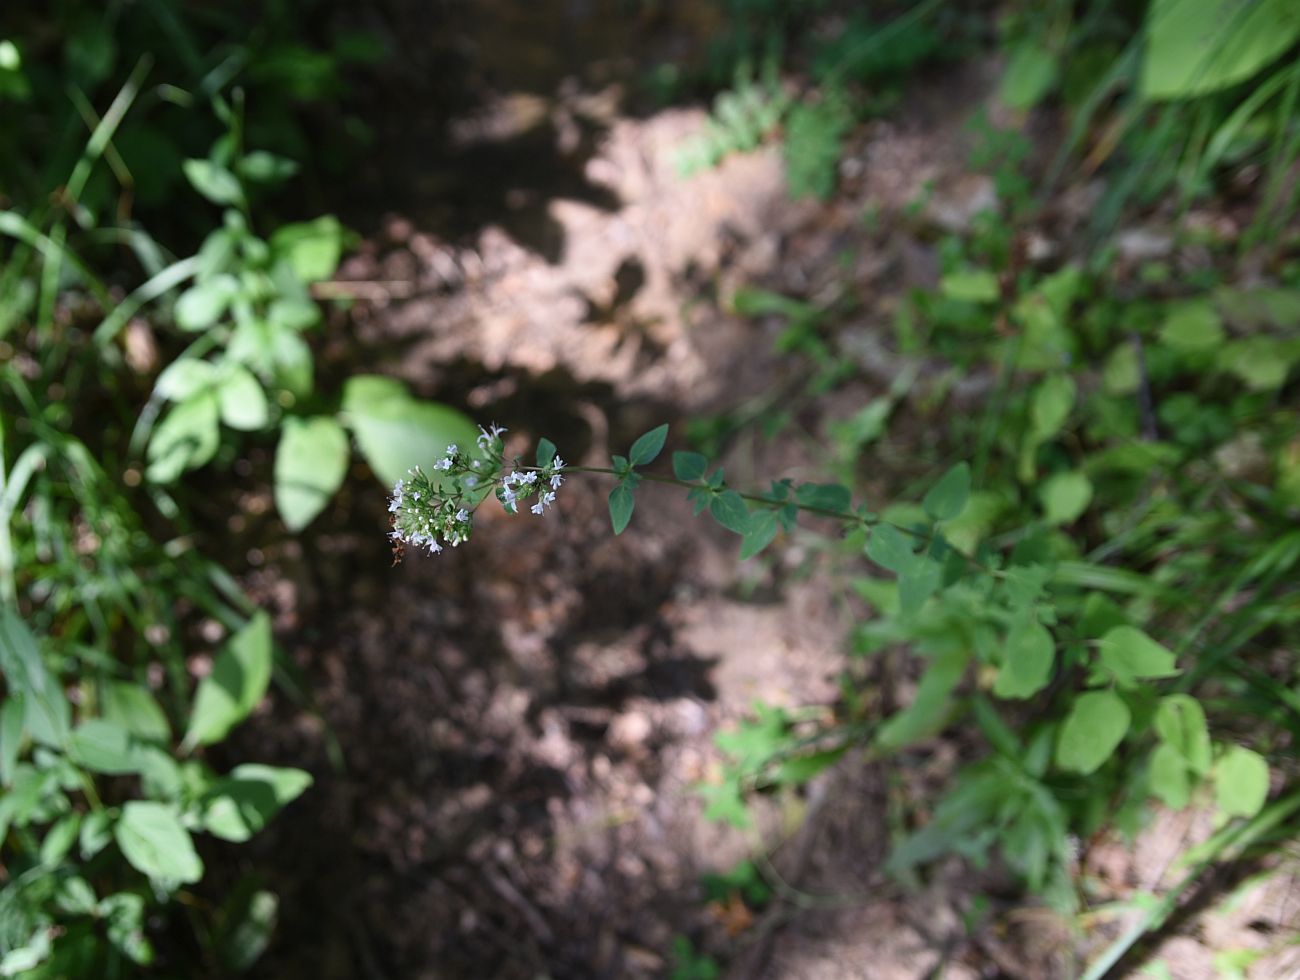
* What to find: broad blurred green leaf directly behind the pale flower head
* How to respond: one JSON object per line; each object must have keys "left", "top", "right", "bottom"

{"left": 342, "top": 374, "right": 478, "bottom": 486}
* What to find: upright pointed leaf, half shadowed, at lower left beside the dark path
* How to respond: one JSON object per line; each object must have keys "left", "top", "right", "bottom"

{"left": 185, "top": 612, "right": 272, "bottom": 749}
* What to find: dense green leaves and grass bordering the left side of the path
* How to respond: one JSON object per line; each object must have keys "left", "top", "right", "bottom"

{"left": 0, "top": 0, "right": 473, "bottom": 977}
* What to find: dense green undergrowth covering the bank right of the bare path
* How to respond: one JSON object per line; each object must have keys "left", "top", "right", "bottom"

{"left": 677, "top": 0, "right": 1300, "bottom": 977}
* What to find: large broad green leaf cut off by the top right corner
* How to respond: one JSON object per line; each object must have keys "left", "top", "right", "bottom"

{"left": 1140, "top": 0, "right": 1300, "bottom": 100}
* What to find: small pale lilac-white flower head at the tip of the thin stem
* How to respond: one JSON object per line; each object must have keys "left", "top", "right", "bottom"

{"left": 389, "top": 425, "right": 564, "bottom": 559}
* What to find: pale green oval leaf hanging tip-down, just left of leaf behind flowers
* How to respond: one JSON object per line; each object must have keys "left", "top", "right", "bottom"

{"left": 276, "top": 415, "right": 351, "bottom": 532}
